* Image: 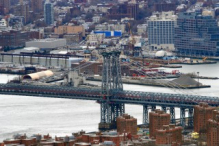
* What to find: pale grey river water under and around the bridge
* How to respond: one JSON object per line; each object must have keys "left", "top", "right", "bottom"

{"left": 0, "top": 64, "right": 219, "bottom": 141}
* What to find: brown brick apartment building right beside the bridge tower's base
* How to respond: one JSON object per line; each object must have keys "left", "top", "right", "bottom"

{"left": 116, "top": 114, "right": 137, "bottom": 135}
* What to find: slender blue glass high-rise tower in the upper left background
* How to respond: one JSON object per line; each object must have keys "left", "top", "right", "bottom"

{"left": 44, "top": 1, "right": 54, "bottom": 25}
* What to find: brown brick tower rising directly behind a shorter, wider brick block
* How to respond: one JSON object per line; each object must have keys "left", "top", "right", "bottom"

{"left": 149, "top": 109, "right": 170, "bottom": 138}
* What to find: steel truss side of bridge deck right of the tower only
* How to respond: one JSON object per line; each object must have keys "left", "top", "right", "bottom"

{"left": 113, "top": 91, "right": 219, "bottom": 106}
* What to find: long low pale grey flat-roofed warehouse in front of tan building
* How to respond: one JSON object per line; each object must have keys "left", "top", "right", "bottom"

{"left": 26, "top": 38, "right": 67, "bottom": 50}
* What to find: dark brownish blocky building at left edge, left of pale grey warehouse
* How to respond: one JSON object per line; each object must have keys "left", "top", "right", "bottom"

{"left": 0, "top": 30, "right": 28, "bottom": 49}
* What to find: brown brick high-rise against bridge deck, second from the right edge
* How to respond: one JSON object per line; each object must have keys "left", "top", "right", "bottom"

{"left": 193, "top": 102, "right": 215, "bottom": 133}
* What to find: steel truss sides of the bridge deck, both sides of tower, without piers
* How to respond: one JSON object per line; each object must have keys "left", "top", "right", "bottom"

{"left": 0, "top": 83, "right": 219, "bottom": 107}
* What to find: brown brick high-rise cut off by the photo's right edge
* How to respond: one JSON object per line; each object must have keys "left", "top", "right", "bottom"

{"left": 207, "top": 110, "right": 219, "bottom": 146}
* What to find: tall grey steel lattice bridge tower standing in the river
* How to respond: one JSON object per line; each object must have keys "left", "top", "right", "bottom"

{"left": 99, "top": 51, "right": 125, "bottom": 129}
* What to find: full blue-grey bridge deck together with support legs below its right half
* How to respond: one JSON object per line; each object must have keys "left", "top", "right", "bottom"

{"left": 0, "top": 83, "right": 219, "bottom": 125}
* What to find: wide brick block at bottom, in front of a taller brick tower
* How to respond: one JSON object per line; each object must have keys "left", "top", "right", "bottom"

{"left": 156, "top": 124, "right": 182, "bottom": 146}
